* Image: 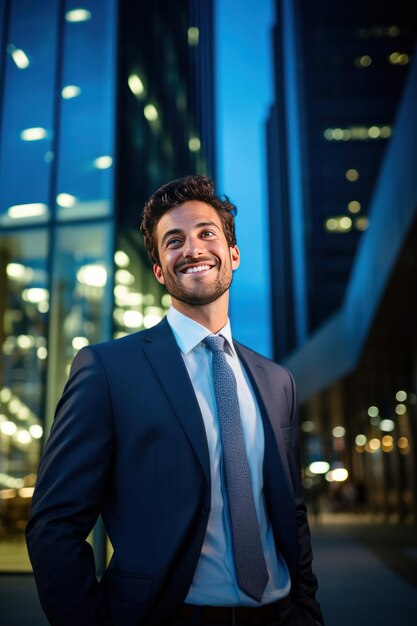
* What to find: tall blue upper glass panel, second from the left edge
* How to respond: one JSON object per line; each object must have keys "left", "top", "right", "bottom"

{"left": 56, "top": 0, "right": 117, "bottom": 220}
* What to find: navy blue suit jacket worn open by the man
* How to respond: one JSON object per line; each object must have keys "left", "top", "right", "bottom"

{"left": 26, "top": 320, "right": 321, "bottom": 626}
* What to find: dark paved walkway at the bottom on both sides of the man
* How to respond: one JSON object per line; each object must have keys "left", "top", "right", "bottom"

{"left": 0, "top": 515, "right": 417, "bottom": 626}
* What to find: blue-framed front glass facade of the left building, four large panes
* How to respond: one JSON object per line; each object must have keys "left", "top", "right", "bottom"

{"left": 0, "top": 0, "right": 117, "bottom": 571}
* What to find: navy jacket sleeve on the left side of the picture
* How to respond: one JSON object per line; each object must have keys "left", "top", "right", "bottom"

{"left": 26, "top": 348, "right": 113, "bottom": 626}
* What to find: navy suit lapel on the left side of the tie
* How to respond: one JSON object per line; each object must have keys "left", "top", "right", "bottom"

{"left": 141, "top": 319, "right": 210, "bottom": 486}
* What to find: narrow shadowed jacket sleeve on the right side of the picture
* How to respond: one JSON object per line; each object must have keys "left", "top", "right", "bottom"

{"left": 287, "top": 370, "right": 324, "bottom": 624}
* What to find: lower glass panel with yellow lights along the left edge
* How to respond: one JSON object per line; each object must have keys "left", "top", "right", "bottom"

{"left": 0, "top": 230, "right": 49, "bottom": 571}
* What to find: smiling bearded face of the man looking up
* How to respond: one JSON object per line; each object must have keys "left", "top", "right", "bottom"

{"left": 153, "top": 200, "right": 240, "bottom": 306}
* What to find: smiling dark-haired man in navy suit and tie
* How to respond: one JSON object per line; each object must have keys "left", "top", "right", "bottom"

{"left": 27, "top": 176, "right": 323, "bottom": 626}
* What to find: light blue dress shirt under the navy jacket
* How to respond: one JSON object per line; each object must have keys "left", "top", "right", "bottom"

{"left": 167, "top": 307, "right": 291, "bottom": 606}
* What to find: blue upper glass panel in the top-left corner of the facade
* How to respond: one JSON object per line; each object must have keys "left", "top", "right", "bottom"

{"left": 0, "top": 0, "right": 58, "bottom": 225}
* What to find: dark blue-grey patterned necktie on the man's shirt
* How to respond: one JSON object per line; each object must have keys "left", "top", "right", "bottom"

{"left": 203, "top": 336, "right": 269, "bottom": 602}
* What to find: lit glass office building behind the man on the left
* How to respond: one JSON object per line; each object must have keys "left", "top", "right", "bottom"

{"left": 0, "top": 0, "right": 214, "bottom": 571}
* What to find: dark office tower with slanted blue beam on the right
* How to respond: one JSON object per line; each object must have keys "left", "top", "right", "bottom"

{"left": 268, "top": 0, "right": 417, "bottom": 523}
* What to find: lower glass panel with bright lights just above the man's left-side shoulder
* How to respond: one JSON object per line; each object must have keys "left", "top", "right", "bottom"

{"left": 47, "top": 223, "right": 113, "bottom": 429}
